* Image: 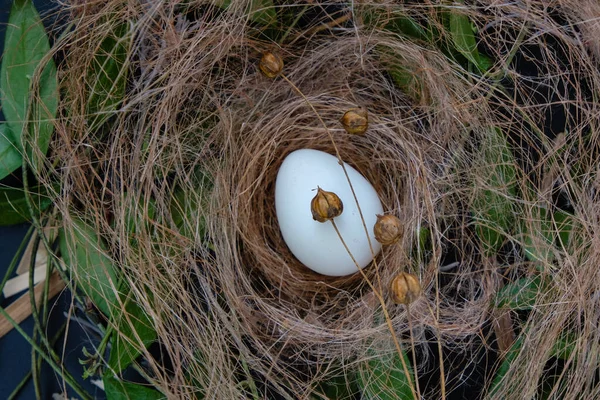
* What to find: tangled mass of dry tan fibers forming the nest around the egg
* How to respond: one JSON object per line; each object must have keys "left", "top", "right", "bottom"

{"left": 34, "top": 0, "right": 600, "bottom": 399}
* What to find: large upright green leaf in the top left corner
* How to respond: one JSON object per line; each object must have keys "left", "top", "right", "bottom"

{"left": 0, "top": 0, "right": 58, "bottom": 176}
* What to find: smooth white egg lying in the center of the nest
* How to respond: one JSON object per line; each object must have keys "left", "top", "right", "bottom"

{"left": 275, "top": 149, "right": 383, "bottom": 276}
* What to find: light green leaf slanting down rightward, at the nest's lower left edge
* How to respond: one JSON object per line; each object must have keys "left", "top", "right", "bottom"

{"left": 59, "top": 218, "right": 120, "bottom": 317}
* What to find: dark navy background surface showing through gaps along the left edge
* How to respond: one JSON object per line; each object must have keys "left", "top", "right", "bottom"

{"left": 0, "top": 0, "right": 105, "bottom": 400}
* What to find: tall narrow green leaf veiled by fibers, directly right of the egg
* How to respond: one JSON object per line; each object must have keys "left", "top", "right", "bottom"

{"left": 472, "top": 129, "right": 516, "bottom": 257}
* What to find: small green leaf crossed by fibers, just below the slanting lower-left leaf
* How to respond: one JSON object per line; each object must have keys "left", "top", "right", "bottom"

{"left": 108, "top": 299, "right": 157, "bottom": 372}
